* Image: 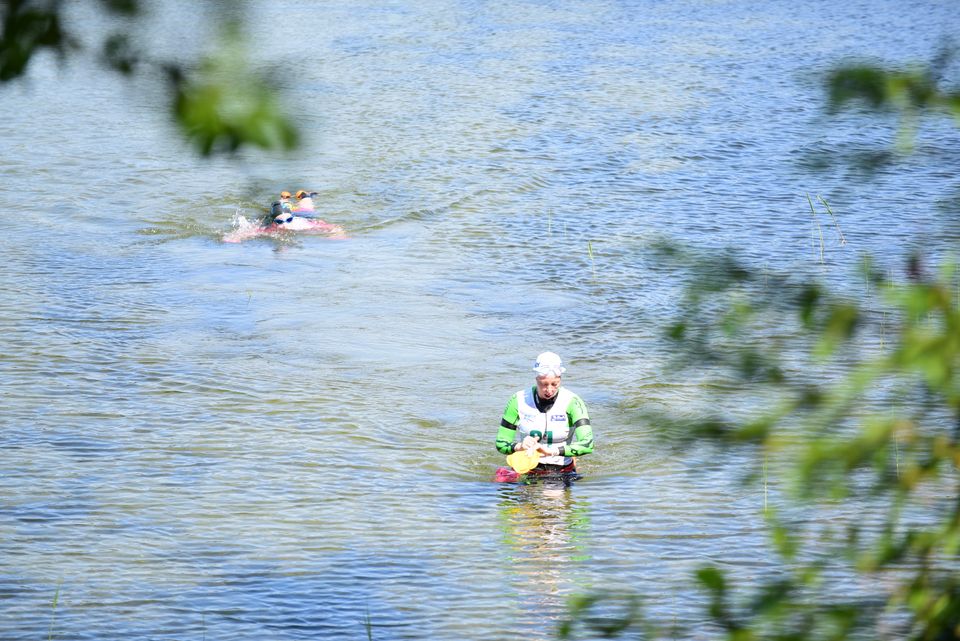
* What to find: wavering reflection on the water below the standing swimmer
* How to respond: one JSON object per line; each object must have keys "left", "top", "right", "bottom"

{"left": 499, "top": 478, "right": 591, "bottom": 639}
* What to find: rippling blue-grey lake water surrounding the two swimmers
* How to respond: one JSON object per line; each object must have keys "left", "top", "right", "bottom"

{"left": 0, "top": 0, "right": 960, "bottom": 641}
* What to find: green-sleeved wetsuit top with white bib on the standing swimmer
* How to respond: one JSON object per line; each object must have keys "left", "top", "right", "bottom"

{"left": 497, "top": 386, "right": 593, "bottom": 465}
